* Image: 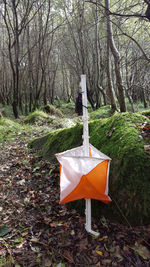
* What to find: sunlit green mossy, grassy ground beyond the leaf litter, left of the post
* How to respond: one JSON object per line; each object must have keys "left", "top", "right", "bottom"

{"left": 0, "top": 107, "right": 78, "bottom": 142}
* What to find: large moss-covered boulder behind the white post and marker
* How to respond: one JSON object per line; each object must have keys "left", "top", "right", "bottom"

{"left": 30, "top": 113, "right": 150, "bottom": 224}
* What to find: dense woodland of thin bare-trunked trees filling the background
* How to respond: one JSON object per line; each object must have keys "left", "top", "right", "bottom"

{"left": 0, "top": 0, "right": 150, "bottom": 118}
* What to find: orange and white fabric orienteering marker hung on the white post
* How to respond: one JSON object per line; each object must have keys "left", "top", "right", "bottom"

{"left": 56, "top": 144, "right": 111, "bottom": 204}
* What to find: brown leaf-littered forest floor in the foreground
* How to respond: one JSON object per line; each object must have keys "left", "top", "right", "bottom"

{"left": 0, "top": 129, "right": 150, "bottom": 267}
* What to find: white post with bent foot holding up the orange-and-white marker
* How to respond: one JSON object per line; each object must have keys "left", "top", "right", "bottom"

{"left": 80, "top": 75, "right": 99, "bottom": 236}
